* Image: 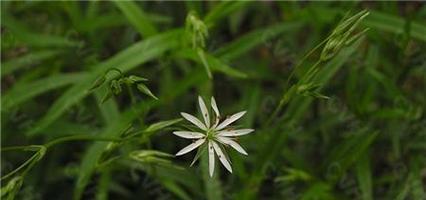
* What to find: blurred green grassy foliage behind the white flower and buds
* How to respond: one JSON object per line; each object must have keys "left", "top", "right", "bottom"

{"left": 1, "top": 1, "right": 426, "bottom": 200}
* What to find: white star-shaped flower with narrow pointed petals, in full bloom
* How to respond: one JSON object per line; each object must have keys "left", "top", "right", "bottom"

{"left": 173, "top": 96, "right": 254, "bottom": 176}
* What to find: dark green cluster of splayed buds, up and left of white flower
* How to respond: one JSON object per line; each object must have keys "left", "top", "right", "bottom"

{"left": 89, "top": 68, "right": 158, "bottom": 103}
